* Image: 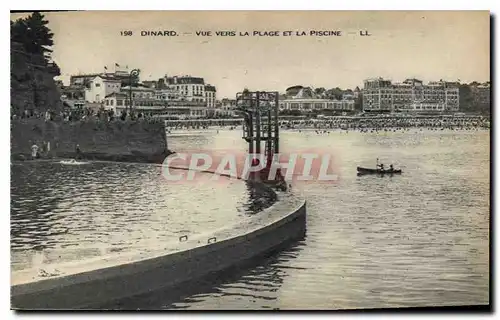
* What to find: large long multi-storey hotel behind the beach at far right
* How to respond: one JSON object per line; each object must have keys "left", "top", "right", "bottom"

{"left": 363, "top": 78, "right": 459, "bottom": 113}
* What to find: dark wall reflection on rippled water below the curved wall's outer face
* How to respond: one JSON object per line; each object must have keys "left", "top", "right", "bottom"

{"left": 102, "top": 240, "right": 304, "bottom": 310}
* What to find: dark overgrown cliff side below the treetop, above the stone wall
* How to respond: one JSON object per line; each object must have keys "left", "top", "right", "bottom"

{"left": 10, "top": 42, "right": 62, "bottom": 114}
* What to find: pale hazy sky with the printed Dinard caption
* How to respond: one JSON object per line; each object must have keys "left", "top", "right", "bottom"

{"left": 11, "top": 11, "right": 490, "bottom": 98}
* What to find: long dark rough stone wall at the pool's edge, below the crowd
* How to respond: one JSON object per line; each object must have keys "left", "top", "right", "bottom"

{"left": 11, "top": 118, "right": 171, "bottom": 163}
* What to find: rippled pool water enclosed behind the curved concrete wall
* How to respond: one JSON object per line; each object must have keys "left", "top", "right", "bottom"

{"left": 11, "top": 162, "right": 275, "bottom": 270}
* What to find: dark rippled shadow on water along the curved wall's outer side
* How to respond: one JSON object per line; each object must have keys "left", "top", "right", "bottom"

{"left": 99, "top": 238, "right": 306, "bottom": 310}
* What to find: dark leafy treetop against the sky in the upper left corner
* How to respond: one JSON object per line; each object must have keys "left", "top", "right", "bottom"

{"left": 10, "top": 12, "right": 54, "bottom": 61}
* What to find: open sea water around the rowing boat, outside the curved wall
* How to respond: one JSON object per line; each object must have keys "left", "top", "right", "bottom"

{"left": 147, "top": 130, "right": 490, "bottom": 310}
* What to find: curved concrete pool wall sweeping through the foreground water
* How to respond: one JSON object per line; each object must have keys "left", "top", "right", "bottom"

{"left": 11, "top": 167, "right": 306, "bottom": 310}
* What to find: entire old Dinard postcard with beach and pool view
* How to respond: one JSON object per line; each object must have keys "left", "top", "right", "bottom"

{"left": 10, "top": 11, "right": 491, "bottom": 311}
